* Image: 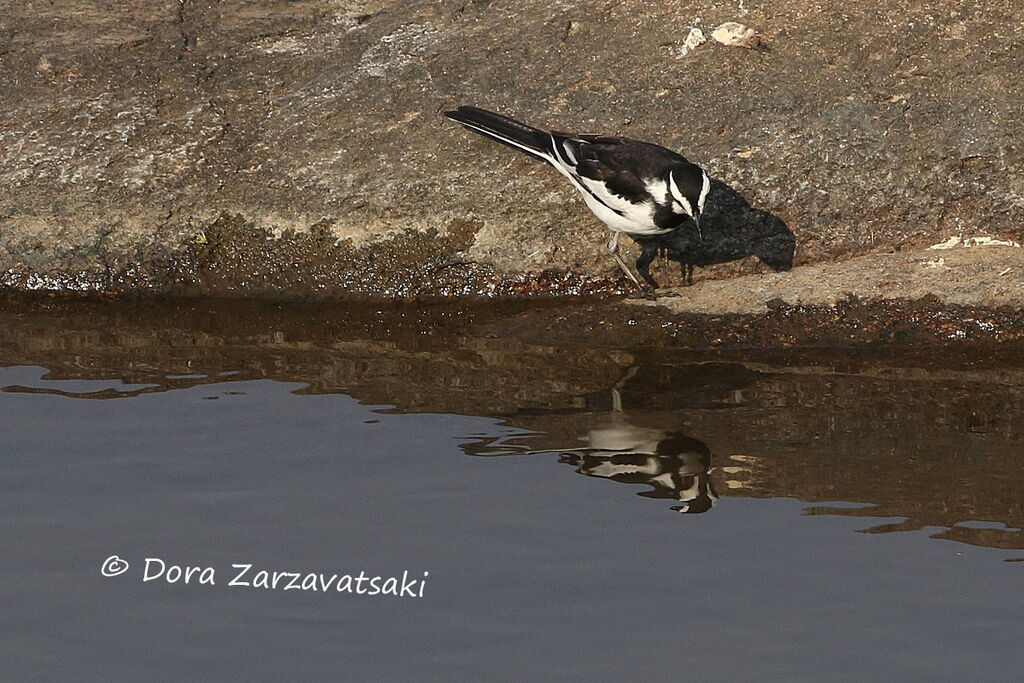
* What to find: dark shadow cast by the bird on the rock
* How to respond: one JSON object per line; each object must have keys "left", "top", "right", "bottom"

{"left": 669, "top": 179, "right": 797, "bottom": 270}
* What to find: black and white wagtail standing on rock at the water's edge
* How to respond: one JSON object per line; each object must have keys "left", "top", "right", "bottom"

{"left": 444, "top": 106, "right": 711, "bottom": 289}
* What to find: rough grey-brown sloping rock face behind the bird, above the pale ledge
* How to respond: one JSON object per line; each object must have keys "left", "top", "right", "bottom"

{"left": 0, "top": 0, "right": 1024, "bottom": 301}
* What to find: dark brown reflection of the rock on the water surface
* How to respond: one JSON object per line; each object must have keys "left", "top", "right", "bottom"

{"left": 0, "top": 300, "right": 1024, "bottom": 548}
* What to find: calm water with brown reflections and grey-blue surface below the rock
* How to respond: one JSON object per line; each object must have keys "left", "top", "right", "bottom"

{"left": 0, "top": 303, "right": 1024, "bottom": 680}
